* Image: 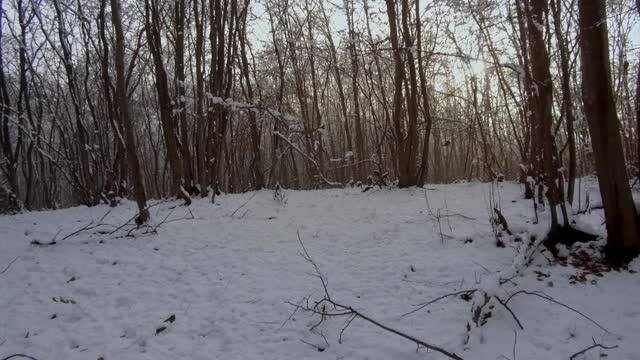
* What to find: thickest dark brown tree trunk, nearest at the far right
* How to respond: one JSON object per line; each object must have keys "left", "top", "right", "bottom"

{"left": 578, "top": 0, "right": 640, "bottom": 262}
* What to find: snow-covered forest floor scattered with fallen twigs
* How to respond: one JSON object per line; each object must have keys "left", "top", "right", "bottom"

{"left": 0, "top": 183, "right": 640, "bottom": 360}
